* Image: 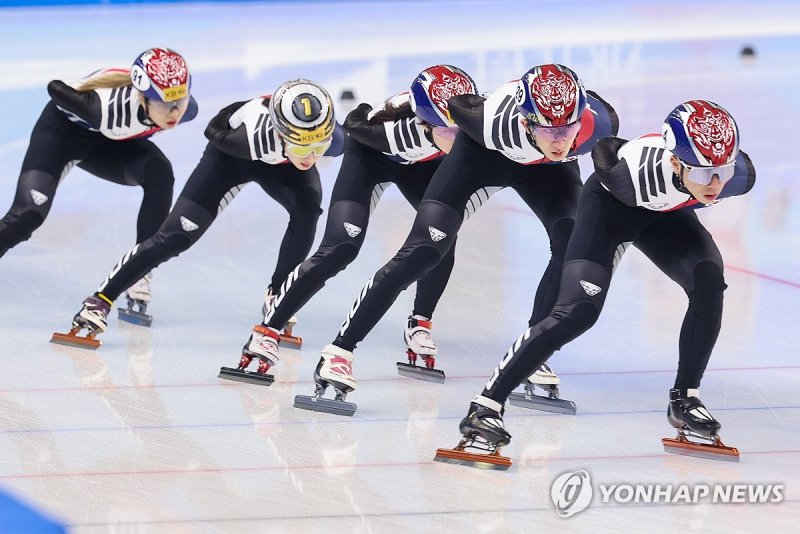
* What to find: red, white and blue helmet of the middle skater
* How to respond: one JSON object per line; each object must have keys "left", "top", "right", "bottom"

{"left": 411, "top": 65, "right": 477, "bottom": 126}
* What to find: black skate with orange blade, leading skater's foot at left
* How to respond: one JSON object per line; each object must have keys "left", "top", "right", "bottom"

{"left": 433, "top": 397, "right": 511, "bottom": 470}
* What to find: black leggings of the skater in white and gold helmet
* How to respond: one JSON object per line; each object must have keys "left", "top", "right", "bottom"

{"left": 97, "top": 144, "right": 322, "bottom": 301}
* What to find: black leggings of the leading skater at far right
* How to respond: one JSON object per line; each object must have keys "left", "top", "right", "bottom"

{"left": 483, "top": 175, "right": 727, "bottom": 403}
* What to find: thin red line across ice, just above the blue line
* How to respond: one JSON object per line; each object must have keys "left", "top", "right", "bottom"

{"left": 0, "top": 364, "right": 800, "bottom": 395}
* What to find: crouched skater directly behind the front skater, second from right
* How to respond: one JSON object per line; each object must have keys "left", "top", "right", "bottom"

{"left": 295, "top": 64, "right": 618, "bottom": 414}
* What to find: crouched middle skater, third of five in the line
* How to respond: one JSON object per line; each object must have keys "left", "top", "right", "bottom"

{"left": 228, "top": 65, "right": 476, "bottom": 390}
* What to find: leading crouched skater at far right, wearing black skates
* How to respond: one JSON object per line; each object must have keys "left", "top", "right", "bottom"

{"left": 444, "top": 100, "right": 755, "bottom": 463}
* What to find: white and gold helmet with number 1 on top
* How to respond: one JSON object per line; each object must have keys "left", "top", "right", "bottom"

{"left": 269, "top": 79, "right": 335, "bottom": 145}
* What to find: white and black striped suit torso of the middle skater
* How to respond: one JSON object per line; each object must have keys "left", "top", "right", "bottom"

{"left": 344, "top": 92, "right": 444, "bottom": 165}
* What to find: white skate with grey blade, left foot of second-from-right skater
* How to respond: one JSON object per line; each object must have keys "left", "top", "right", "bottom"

{"left": 294, "top": 345, "right": 357, "bottom": 416}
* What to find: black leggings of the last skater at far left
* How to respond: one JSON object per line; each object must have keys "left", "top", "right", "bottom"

{"left": 0, "top": 102, "right": 175, "bottom": 257}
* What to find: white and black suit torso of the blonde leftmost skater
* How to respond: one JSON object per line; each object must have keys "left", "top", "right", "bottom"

{"left": 47, "top": 69, "right": 197, "bottom": 141}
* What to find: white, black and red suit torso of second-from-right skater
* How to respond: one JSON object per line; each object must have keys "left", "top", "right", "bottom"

{"left": 449, "top": 81, "right": 619, "bottom": 165}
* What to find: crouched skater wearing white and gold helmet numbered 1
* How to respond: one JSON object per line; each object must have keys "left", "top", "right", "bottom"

{"left": 54, "top": 79, "right": 345, "bottom": 348}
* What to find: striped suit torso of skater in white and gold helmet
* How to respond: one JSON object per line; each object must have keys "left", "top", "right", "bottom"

{"left": 205, "top": 96, "right": 345, "bottom": 165}
